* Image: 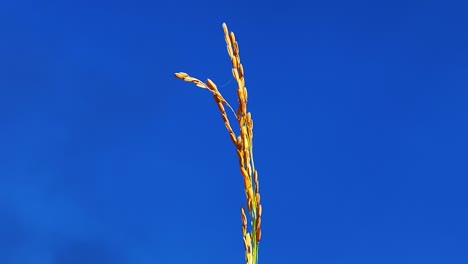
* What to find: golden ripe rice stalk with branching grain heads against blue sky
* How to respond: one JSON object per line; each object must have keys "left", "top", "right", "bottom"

{"left": 175, "top": 23, "right": 262, "bottom": 264}
